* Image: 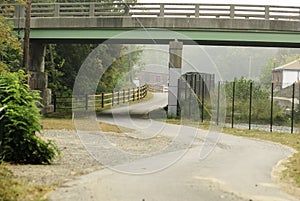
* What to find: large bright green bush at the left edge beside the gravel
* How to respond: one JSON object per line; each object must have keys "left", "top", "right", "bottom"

{"left": 0, "top": 71, "right": 60, "bottom": 164}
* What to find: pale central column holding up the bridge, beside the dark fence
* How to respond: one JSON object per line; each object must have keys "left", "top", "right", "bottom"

{"left": 168, "top": 41, "right": 183, "bottom": 117}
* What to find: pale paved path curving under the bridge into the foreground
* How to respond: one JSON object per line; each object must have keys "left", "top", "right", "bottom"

{"left": 50, "top": 94, "right": 299, "bottom": 201}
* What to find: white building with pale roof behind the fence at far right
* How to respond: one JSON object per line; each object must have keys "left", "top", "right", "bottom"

{"left": 272, "top": 59, "right": 300, "bottom": 90}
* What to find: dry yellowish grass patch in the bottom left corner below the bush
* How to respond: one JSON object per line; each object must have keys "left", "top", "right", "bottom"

{"left": 0, "top": 163, "right": 51, "bottom": 201}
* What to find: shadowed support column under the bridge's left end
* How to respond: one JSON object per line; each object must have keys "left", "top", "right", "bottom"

{"left": 29, "top": 43, "right": 54, "bottom": 113}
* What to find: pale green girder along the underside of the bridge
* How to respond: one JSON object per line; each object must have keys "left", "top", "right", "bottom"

{"left": 24, "top": 28, "right": 300, "bottom": 48}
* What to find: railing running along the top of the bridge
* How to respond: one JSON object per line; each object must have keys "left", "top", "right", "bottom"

{"left": 0, "top": 2, "right": 300, "bottom": 20}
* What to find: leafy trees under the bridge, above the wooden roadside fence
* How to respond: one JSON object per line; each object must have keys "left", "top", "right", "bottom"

{"left": 46, "top": 44, "right": 141, "bottom": 95}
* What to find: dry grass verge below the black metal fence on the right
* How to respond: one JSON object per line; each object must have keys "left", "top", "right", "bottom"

{"left": 166, "top": 119, "right": 300, "bottom": 188}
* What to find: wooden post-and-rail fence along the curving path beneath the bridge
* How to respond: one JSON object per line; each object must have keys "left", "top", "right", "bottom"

{"left": 53, "top": 85, "right": 148, "bottom": 112}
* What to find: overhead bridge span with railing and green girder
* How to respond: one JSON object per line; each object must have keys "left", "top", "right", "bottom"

{"left": 6, "top": 2, "right": 300, "bottom": 47}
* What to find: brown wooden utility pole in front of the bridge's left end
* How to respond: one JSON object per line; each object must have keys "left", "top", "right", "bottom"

{"left": 23, "top": 0, "right": 31, "bottom": 74}
